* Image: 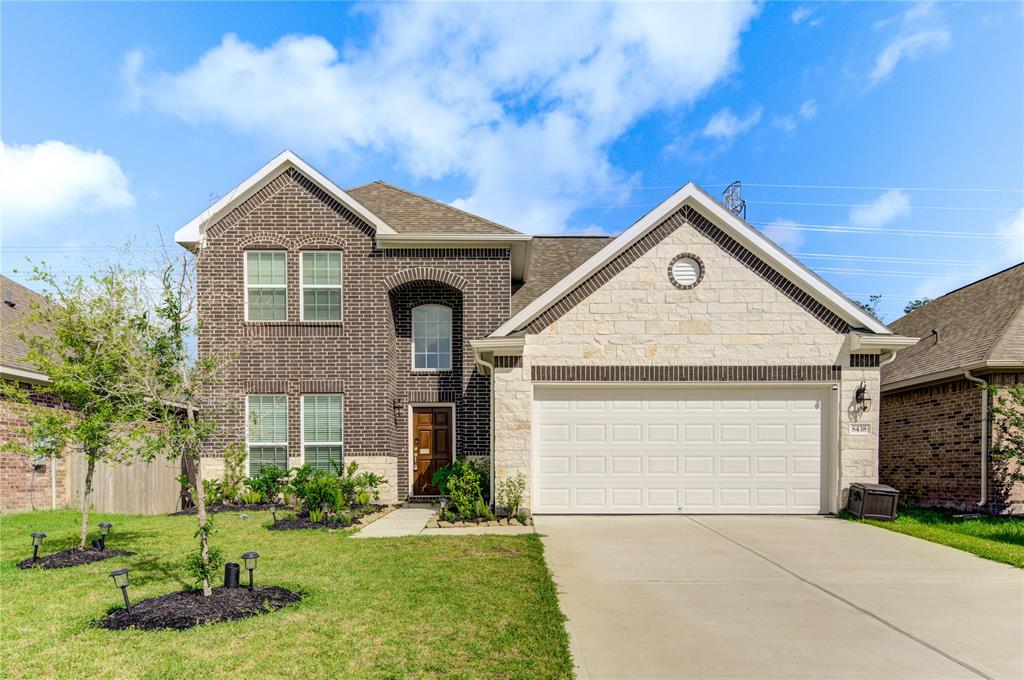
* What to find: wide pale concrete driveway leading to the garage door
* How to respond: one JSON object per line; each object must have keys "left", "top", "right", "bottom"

{"left": 537, "top": 516, "right": 1024, "bottom": 680}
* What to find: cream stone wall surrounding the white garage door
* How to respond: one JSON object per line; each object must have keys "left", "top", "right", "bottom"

{"left": 495, "top": 209, "right": 879, "bottom": 512}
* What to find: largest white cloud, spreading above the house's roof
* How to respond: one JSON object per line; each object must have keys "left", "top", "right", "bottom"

{"left": 124, "top": 3, "right": 758, "bottom": 231}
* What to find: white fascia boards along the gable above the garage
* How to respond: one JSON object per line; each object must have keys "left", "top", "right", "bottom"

{"left": 492, "top": 182, "right": 892, "bottom": 337}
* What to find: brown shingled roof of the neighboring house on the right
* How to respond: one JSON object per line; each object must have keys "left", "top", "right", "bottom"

{"left": 882, "top": 262, "right": 1024, "bottom": 386}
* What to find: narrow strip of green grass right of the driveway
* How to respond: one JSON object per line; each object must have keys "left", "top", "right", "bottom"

{"left": 847, "top": 508, "right": 1024, "bottom": 568}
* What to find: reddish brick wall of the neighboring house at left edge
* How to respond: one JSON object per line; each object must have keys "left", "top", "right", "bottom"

{"left": 0, "top": 384, "right": 68, "bottom": 512}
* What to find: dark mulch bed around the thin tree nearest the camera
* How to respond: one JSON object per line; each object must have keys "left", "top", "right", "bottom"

{"left": 93, "top": 586, "right": 302, "bottom": 631}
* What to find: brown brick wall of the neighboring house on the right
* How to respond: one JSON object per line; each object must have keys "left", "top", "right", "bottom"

{"left": 879, "top": 374, "right": 1024, "bottom": 512}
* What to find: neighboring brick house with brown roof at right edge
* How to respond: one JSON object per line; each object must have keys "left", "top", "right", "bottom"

{"left": 880, "top": 263, "right": 1024, "bottom": 512}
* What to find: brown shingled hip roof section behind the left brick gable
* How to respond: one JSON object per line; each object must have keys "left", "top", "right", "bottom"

{"left": 347, "top": 180, "right": 519, "bottom": 235}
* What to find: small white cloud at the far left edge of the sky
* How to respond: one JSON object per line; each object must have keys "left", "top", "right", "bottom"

{"left": 0, "top": 140, "right": 135, "bottom": 236}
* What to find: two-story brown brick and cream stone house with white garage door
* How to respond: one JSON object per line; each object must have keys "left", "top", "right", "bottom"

{"left": 175, "top": 152, "right": 915, "bottom": 513}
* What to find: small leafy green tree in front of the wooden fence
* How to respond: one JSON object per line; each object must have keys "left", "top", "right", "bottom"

{"left": 14, "top": 264, "right": 150, "bottom": 548}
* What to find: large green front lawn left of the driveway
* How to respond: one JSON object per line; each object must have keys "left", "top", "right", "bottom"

{"left": 0, "top": 510, "right": 572, "bottom": 679}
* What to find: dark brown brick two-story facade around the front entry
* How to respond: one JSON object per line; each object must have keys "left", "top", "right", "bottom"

{"left": 193, "top": 170, "right": 510, "bottom": 498}
